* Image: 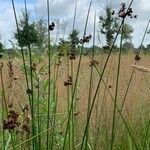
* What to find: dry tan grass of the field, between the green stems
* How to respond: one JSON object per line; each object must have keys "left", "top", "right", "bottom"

{"left": 0, "top": 54, "right": 150, "bottom": 149}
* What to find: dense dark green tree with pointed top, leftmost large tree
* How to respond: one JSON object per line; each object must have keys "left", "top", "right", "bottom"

{"left": 15, "top": 12, "right": 41, "bottom": 47}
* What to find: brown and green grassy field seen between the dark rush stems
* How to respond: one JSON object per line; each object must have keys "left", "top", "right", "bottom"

{"left": 0, "top": 53, "right": 150, "bottom": 150}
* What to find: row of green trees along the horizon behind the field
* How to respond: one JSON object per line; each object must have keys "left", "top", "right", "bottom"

{"left": 0, "top": 6, "right": 150, "bottom": 56}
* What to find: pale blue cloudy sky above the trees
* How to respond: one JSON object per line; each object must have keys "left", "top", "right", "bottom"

{"left": 0, "top": 0, "right": 150, "bottom": 47}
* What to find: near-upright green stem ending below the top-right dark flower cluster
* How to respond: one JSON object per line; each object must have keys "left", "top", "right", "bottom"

{"left": 110, "top": 19, "right": 124, "bottom": 150}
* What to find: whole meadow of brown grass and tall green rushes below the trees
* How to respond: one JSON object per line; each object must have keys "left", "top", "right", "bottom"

{"left": 0, "top": 0, "right": 150, "bottom": 150}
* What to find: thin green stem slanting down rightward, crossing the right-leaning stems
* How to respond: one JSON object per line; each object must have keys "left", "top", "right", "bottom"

{"left": 94, "top": 65, "right": 139, "bottom": 150}
